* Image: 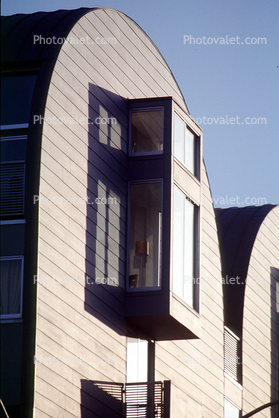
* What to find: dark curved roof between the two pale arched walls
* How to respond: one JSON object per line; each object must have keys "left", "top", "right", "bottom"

{"left": 215, "top": 204, "right": 276, "bottom": 336}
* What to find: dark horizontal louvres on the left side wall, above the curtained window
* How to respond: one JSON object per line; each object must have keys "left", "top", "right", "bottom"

{"left": 0, "top": 163, "right": 25, "bottom": 216}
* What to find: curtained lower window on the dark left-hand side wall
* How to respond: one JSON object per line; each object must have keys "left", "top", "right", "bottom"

{"left": 0, "top": 257, "right": 23, "bottom": 319}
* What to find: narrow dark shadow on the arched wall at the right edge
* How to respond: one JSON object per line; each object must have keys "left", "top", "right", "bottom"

{"left": 270, "top": 267, "right": 279, "bottom": 418}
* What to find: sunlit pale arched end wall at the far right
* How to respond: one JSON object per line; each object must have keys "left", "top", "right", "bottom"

{"left": 242, "top": 206, "right": 279, "bottom": 416}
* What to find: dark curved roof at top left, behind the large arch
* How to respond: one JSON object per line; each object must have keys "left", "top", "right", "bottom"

{"left": 1, "top": 8, "right": 94, "bottom": 62}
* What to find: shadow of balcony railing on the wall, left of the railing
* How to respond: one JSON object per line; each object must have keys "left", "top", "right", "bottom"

{"left": 81, "top": 380, "right": 125, "bottom": 418}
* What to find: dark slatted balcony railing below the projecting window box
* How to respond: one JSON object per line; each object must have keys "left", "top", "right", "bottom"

{"left": 125, "top": 382, "right": 164, "bottom": 418}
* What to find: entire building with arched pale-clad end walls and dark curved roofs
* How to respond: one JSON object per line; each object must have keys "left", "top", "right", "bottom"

{"left": 1, "top": 8, "right": 279, "bottom": 418}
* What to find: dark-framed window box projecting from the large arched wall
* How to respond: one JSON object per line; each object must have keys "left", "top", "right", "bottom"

{"left": 126, "top": 97, "right": 202, "bottom": 341}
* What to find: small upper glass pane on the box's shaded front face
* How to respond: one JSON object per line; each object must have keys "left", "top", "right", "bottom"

{"left": 131, "top": 110, "right": 163, "bottom": 153}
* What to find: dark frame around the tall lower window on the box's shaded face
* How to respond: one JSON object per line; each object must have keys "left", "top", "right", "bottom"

{"left": 126, "top": 178, "right": 164, "bottom": 292}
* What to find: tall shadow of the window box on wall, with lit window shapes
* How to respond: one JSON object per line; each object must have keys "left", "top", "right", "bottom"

{"left": 84, "top": 83, "right": 128, "bottom": 335}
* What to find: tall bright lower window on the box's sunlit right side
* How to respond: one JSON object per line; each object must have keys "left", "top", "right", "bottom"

{"left": 172, "top": 186, "right": 197, "bottom": 307}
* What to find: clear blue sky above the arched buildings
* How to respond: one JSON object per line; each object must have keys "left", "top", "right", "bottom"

{"left": 1, "top": 0, "right": 279, "bottom": 207}
